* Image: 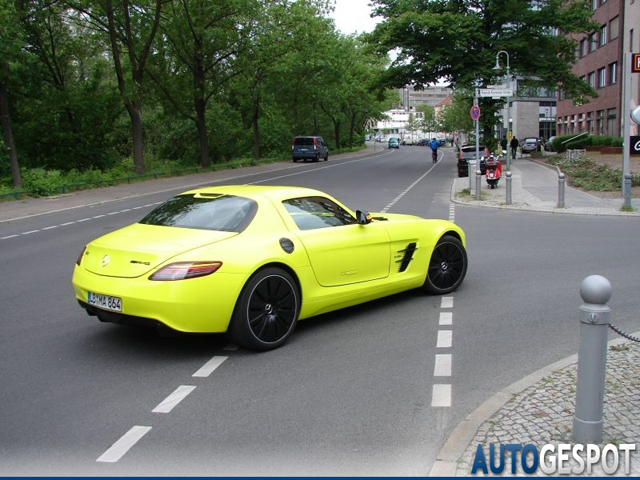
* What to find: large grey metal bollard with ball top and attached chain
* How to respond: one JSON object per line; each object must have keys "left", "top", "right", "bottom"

{"left": 573, "top": 275, "right": 612, "bottom": 444}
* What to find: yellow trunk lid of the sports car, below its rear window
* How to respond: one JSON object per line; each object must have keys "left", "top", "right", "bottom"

{"left": 82, "top": 223, "right": 238, "bottom": 278}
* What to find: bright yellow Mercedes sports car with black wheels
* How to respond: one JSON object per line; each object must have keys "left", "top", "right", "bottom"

{"left": 73, "top": 186, "right": 467, "bottom": 350}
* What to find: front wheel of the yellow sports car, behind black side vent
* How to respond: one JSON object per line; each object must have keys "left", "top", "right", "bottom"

{"left": 423, "top": 235, "right": 468, "bottom": 295}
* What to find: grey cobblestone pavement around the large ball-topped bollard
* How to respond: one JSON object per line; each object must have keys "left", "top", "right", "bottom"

{"left": 455, "top": 342, "right": 640, "bottom": 477}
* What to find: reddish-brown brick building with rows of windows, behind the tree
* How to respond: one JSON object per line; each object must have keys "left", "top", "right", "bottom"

{"left": 556, "top": 0, "right": 620, "bottom": 137}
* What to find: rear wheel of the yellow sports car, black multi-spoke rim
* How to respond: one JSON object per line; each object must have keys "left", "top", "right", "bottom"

{"left": 227, "top": 267, "right": 300, "bottom": 351}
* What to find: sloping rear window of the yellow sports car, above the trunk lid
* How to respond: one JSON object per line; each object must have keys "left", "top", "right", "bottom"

{"left": 140, "top": 193, "right": 258, "bottom": 232}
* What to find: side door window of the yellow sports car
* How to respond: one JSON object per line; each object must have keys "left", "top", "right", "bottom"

{"left": 282, "top": 197, "right": 357, "bottom": 230}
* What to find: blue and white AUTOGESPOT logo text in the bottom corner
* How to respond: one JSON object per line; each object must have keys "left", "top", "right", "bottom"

{"left": 471, "top": 443, "right": 636, "bottom": 475}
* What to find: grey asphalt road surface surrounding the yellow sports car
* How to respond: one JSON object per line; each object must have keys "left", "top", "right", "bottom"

{"left": 0, "top": 147, "right": 640, "bottom": 476}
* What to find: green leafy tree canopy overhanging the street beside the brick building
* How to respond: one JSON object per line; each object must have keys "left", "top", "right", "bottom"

{"left": 368, "top": 0, "right": 599, "bottom": 135}
